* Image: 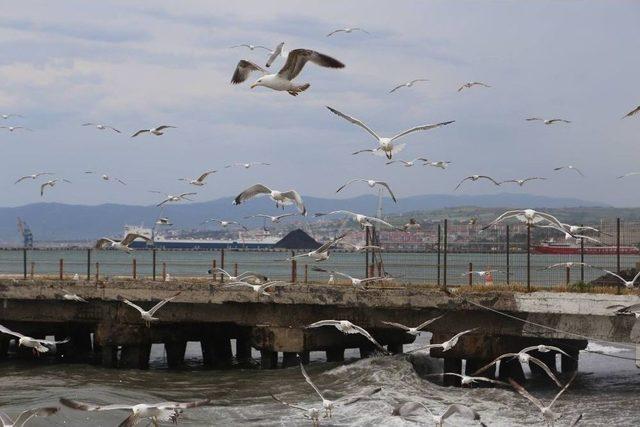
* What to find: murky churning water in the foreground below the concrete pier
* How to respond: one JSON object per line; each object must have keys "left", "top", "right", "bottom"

{"left": 0, "top": 339, "right": 640, "bottom": 426}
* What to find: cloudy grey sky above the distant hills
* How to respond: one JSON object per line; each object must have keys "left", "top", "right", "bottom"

{"left": 0, "top": 0, "right": 640, "bottom": 206}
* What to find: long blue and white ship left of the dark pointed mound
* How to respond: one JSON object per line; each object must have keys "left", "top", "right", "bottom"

{"left": 124, "top": 225, "right": 282, "bottom": 251}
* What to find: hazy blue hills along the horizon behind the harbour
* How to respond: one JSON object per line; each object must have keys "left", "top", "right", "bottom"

{"left": 0, "top": 193, "right": 614, "bottom": 242}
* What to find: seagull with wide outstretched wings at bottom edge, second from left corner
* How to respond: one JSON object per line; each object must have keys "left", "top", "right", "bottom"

{"left": 60, "top": 398, "right": 211, "bottom": 427}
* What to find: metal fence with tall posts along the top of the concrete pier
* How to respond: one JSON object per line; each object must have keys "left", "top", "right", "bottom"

{"left": 0, "top": 220, "right": 640, "bottom": 287}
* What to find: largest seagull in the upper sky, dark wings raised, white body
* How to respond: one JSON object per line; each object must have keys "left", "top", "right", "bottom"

{"left": 231, "top": 49, "right": 344, "bottom": 96}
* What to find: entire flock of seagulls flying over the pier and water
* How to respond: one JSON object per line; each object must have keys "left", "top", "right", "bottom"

{"left": 0, "top": 20, "right": 640, "bottom": 427}
